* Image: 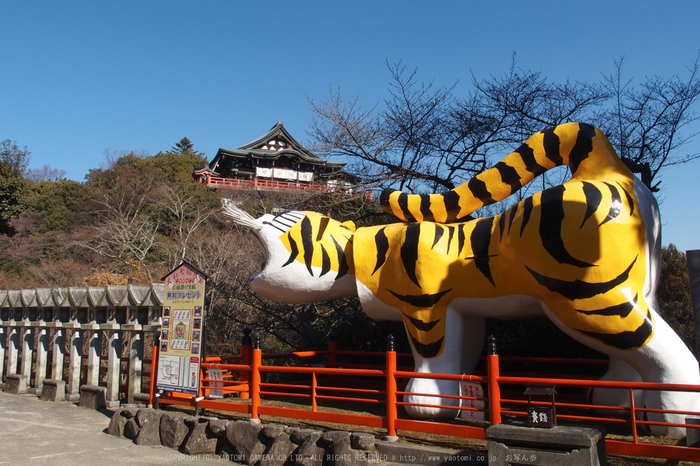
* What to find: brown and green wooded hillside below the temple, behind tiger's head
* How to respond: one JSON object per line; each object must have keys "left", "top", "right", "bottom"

{"left": 0, "top": 141, "right": 407, "bottom": 354}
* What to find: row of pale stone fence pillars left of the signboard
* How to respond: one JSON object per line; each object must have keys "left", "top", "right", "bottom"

{"left": 0, "top": 283, "right": 164, "bottom": 408}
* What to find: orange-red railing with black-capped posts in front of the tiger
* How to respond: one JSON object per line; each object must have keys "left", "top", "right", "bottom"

{"left": 152, "top": 338, "right": 700, "bottom": 461}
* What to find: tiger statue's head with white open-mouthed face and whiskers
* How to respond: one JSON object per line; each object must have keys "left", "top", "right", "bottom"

{"left": 223, "top": 200, "right": 357, "bottom": 303}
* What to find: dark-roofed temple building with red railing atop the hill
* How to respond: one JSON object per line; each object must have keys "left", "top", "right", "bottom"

{"left": 193, "top": 121, "right": 359, "bottom": 194}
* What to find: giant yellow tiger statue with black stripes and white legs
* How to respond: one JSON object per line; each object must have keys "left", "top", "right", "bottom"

{"left": 224, "top": 123, "right": 700, "bottom": 437}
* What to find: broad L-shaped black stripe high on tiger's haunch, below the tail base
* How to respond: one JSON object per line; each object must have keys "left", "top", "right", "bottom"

{"left": 539, "top": 185, "right": 593, "bottom": 268}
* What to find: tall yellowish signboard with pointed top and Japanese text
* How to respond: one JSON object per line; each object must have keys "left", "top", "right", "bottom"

{"left": 156, "top": 262, "right": 207, "bottom": 395}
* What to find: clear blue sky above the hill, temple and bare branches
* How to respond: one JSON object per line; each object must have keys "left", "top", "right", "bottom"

{"left": 0, "top": 0, "right": 700, "bottom": 250}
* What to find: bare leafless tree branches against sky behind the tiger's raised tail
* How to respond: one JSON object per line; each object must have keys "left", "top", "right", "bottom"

{"left": 308, "top": 55, "right": 700, "bottom": 201}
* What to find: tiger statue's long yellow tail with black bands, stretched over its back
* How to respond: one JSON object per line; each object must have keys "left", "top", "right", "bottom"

{"left": 380, "top": 123, "right": 632, "bottom": 223}
